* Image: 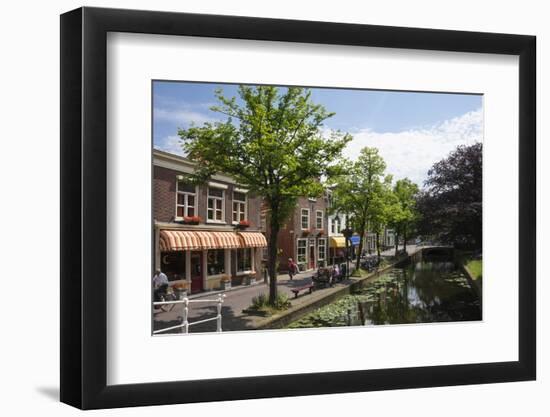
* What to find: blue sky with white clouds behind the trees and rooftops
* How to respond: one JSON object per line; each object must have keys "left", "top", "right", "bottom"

{"left": 153, "top": 81, "right": 483, "bottom": 185}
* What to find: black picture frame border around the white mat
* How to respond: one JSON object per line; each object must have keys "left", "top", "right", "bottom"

{"left": 60, "top": 7, "right": 536, "bottom": 409}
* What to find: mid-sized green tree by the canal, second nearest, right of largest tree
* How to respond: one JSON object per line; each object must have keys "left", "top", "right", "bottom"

{"left": 330, "top": 147, "right": 386, "bottom": 268}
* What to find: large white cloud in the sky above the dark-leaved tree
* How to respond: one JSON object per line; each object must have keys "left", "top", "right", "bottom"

{"left": 344, "top": 109, "right": 483, "bottom": 186}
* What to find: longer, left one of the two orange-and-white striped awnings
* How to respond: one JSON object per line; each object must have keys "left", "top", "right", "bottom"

{"left": 159, "top": 230, "right": 242, "bottom": 252}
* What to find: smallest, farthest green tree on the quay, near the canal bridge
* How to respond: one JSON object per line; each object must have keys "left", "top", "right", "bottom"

{"left": 393, "top": 178, "right": 419, "bottom": 250}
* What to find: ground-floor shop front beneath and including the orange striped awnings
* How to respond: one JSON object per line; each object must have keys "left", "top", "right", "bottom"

{"left": 157, "top": 230, "right": 267, "bottom": 294}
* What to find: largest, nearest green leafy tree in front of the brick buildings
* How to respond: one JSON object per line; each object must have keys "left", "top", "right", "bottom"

{"left": 178, "top": 85, "right": 351, "bottom": 305}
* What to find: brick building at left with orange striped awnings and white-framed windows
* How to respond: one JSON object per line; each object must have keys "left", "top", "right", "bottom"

{"left": 153, "top": 150, "right": 266, "bottom": 293}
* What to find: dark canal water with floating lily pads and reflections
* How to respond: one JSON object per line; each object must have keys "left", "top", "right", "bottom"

{"left": 289, "top": 260, "right": 481, "bottom": 328}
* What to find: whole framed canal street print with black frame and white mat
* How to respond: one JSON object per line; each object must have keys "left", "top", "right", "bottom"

{"left": 61, "top": 8, "right": 536, "bottom": 409}
